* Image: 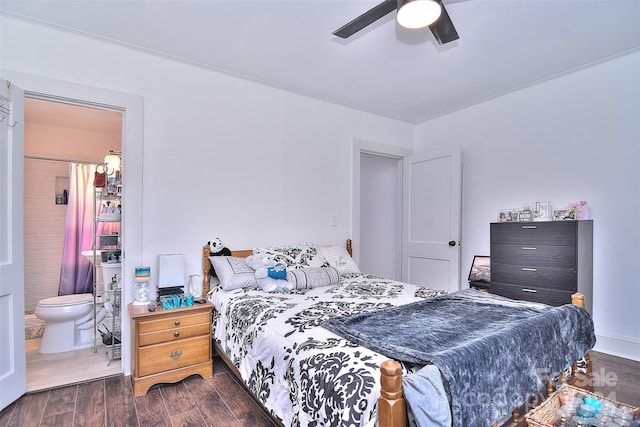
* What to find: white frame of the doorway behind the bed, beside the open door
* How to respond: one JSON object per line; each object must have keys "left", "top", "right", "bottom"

{"left": 351, "top": 138, "right": 413, "bottom": 271}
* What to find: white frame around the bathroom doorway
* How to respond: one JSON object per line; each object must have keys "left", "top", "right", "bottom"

{"left": 2, "top": 69, "right": 144, "bottom": 375}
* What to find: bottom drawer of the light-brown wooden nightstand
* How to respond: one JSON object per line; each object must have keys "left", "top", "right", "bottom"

{"left": 136, "top": 335, "right": 211, "bottom": 377}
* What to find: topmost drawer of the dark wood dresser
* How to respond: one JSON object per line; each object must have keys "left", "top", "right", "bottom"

{"left": 490, "top": 221, "right": 578, "bottom": 246}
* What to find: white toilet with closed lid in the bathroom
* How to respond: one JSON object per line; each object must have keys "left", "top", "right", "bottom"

{"left": 34, "top": 294, "right": 104, "bottom": 353}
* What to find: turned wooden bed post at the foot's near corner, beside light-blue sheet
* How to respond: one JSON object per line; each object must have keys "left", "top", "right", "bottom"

{"left": 378, "top": 360, "right": 407, "bottom": 427}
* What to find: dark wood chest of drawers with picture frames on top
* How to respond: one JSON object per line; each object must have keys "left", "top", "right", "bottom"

{"left": 490, "top": 220, "right": 593, "bottom": 313}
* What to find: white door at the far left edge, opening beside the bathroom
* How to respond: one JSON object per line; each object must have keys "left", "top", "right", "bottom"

{"left": 0, "top": 79, "right": 27, "bottom": 410}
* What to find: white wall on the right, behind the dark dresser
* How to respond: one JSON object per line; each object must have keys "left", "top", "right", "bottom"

{"left": 416, "top": 52, "right": 640, "bottom": 360}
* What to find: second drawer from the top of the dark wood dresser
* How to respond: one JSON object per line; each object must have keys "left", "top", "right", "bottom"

{"left": 491, "top": 244, "right": 576, "bottom": 270}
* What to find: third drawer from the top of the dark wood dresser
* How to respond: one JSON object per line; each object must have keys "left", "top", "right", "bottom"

{"left": 491, "top": 262, "right": 577, "bottom": 292}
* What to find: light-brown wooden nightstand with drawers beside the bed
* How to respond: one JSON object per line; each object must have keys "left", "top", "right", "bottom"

{"left": 129, "top": 302, "right": 213, "bottom": 396}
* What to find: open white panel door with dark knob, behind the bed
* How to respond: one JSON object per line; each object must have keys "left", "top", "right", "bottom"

{"left": 402, "top": 147, "right": 462, "bottom": 291}
